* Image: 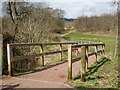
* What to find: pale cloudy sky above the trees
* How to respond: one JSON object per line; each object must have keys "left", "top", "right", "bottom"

{"left": 0, "top": 0, "right": 115, "bottom": 18}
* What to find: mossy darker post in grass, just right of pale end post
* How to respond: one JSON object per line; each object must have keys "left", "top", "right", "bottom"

{"left": 81, "top": 46, "right": 86, "bottom": 82}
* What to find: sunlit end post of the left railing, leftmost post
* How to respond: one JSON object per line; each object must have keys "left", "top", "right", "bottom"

{"left": 7, "top": 44, "right": 13, "bottom": 76}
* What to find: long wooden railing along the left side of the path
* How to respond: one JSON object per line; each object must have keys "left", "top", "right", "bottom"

{"left": 7, "top": 42, "right": 78, "bottom": 76}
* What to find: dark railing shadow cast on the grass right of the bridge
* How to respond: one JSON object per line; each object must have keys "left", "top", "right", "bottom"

{"left": 74, "top": 57, "right": 110, "bottom": 80}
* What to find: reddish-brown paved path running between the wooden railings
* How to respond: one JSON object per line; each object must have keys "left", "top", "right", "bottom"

{"left": 2, "top": 56, "right": 100, "bottom": 88}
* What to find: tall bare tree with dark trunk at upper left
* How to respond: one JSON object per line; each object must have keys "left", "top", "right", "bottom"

{"left": 3, "top": 0, "right": 28, "bottom": 42}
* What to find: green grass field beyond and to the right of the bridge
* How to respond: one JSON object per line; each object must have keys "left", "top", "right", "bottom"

{"left": 64, "top": 32, "right": 118, "bottom": 89}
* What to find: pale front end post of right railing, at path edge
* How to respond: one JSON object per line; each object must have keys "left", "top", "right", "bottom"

{"left": 68, "top": 45, "right": 72, "bottom": 80}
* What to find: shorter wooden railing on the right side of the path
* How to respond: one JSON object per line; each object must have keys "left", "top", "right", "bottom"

{"left": 68, "top": 43, "right": 105, "bottom": 81}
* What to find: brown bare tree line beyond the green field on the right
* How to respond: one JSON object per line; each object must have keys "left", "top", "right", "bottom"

{"left": 74, "top": 14, "right": 118, "bottom": 35}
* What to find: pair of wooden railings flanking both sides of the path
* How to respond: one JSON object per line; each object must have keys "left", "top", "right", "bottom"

{"left": 7, "top": 42, "right": 105, "bottom": 81}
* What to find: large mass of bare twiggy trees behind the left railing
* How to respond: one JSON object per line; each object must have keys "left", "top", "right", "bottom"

{"left": 2, "top": 1, "right": 64, "bottom": 74}
